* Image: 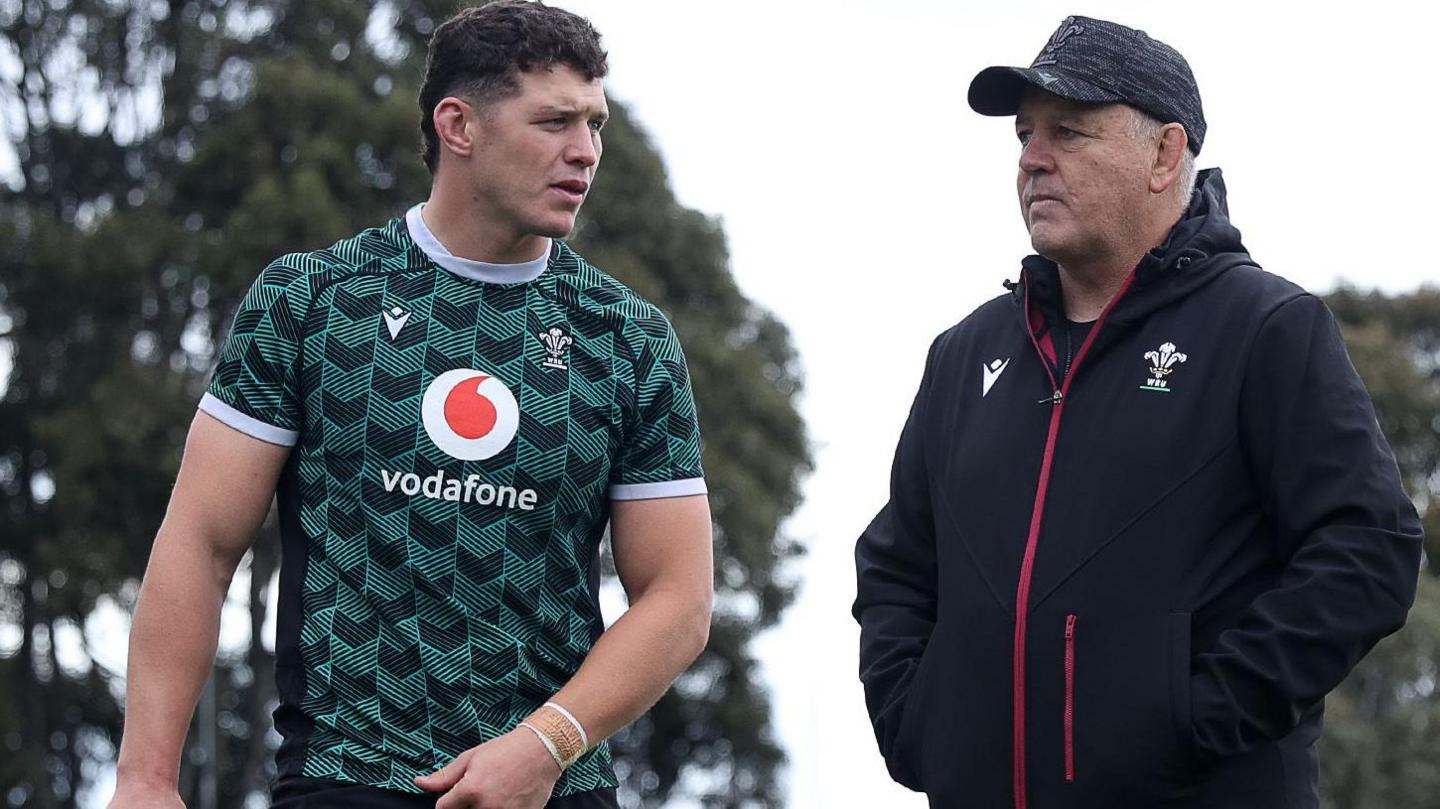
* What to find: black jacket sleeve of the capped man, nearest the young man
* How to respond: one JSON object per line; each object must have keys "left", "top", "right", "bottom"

{"left": 852, "top": 333, "right": 939, "bottom": 789}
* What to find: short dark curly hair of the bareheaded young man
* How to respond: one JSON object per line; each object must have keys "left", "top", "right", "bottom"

{"left": 420, "top": 0, "right": 609, "bottom": 174}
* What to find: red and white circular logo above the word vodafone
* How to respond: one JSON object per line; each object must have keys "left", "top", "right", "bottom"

{"left": 420, "top": 369, "right": 520, "bottom": 461}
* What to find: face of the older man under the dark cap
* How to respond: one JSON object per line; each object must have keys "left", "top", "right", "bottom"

{"left": 1015, "top": 88, "right": 1153, "bottom": 263}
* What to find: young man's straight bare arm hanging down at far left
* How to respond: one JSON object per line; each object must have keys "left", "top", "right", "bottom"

{"left": 111, "top": 412, "right": 289, "bottom": 809}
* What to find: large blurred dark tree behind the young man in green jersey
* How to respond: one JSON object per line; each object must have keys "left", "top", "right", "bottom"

{"left": 0, "top": 0, "right": 809, "bottom": 806}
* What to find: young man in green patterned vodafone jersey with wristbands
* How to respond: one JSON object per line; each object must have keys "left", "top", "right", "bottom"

{"left": 111, "top": 0, "right": 711, "bottom": 809}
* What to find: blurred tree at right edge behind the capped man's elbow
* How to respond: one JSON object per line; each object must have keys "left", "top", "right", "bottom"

{"left": 1320, "top": 288, "right": 1440, "bottom": 809}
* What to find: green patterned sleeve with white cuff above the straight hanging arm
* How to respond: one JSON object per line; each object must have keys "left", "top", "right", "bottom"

{"left": 200, "top": 262, "right": 310, "bottom": 446}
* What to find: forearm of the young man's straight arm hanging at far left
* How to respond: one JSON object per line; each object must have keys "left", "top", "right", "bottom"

{"left": 117, "top": 520, "right": 238, "bottom": 786}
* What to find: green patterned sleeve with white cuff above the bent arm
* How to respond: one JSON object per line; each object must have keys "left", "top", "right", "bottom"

{"left": 609, "top": 312, "right": 706, "bottom": 500}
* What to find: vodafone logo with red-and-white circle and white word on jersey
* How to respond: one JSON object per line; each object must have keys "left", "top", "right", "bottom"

{"left": 380, "top": 369, "right": 539, "bottom": 511}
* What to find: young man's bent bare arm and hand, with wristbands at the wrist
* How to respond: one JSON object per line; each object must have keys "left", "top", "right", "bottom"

{"left": 418, "top": 495, "right": 713, "bottom": 809}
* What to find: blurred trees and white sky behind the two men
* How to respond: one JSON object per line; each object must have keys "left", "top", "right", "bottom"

{"left": 0, "top": 0, "right": 1440, "bottom": 809}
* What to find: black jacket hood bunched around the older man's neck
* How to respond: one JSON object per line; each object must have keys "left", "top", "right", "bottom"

{"left": 1015, "top": 168, "right": 1257, "bottom": 324}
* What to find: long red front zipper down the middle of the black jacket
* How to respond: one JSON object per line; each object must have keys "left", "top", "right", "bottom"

{"left": 1011, "top": 272, "right": 1135, "bottom": 809}
